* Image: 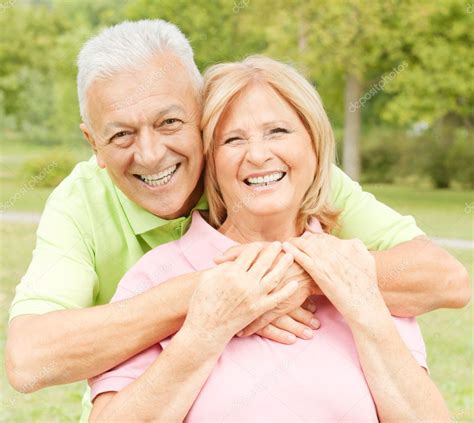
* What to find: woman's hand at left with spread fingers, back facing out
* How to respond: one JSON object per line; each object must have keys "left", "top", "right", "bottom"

{"left": 183, "top": 242, "right": 298, "bottom": 344}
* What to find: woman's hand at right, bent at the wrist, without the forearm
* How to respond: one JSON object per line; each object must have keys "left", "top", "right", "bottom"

{"left": 283, "top": 234, "right": 385, "bottom": 320}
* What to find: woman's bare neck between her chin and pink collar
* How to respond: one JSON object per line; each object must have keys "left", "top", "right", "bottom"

{"left": 219, "top": 213, "right": 304, "bottom": 244}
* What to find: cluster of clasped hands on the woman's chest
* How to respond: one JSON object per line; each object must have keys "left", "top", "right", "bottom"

{"left": 185, "top": 234, "right": 383, "bottom": 344}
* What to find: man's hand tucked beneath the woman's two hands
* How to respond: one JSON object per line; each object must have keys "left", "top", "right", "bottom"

{"left": 214, "top": 244, "right": 321, "bottom": 344}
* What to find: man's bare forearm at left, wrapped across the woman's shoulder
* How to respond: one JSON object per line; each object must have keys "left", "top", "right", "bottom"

{"left": 6, "top": 273, "right": 199, "bottom": 392}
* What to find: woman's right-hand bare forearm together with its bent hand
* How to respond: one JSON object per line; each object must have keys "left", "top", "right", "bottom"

{"left": 284, "top": 235, "right": 449, "bottom": 421}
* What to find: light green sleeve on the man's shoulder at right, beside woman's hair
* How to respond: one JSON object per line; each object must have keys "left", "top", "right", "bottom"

{"left": 331, "top": 165, "right": 425, "bottom": 251}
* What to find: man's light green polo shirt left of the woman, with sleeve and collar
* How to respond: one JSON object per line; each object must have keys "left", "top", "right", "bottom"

{"left": 10, "top": 156, "right": 208, "bottom": 319}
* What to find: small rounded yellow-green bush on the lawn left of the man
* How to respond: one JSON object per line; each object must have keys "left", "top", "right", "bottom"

{"left": 23, "top": 150, "right": 76, "bottom": 187}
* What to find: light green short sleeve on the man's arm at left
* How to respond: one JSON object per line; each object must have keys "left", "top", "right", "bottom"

{"left": 10, "top": 197, "right": 98, "bottom": 320}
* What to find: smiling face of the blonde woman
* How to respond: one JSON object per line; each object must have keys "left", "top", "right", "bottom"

{"left": 214, "top": 83, "right": 316, "bottom": 219}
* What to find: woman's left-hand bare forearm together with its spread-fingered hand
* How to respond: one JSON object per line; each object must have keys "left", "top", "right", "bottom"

{"left": 91, "top": 243, "right": 298, "bottom": 421}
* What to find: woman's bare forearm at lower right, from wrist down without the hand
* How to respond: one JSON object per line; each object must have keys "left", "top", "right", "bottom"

{"left": 348, "top": 301, "right": 450, "bottom": 422}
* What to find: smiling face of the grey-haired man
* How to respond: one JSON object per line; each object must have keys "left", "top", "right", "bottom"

{"left": 81, "top": 53, "right": 204, "bottom": 219}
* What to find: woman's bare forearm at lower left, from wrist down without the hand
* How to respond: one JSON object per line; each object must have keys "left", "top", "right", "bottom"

{"left": 89, "top": 325, "right": 226, "bottom": 422}
